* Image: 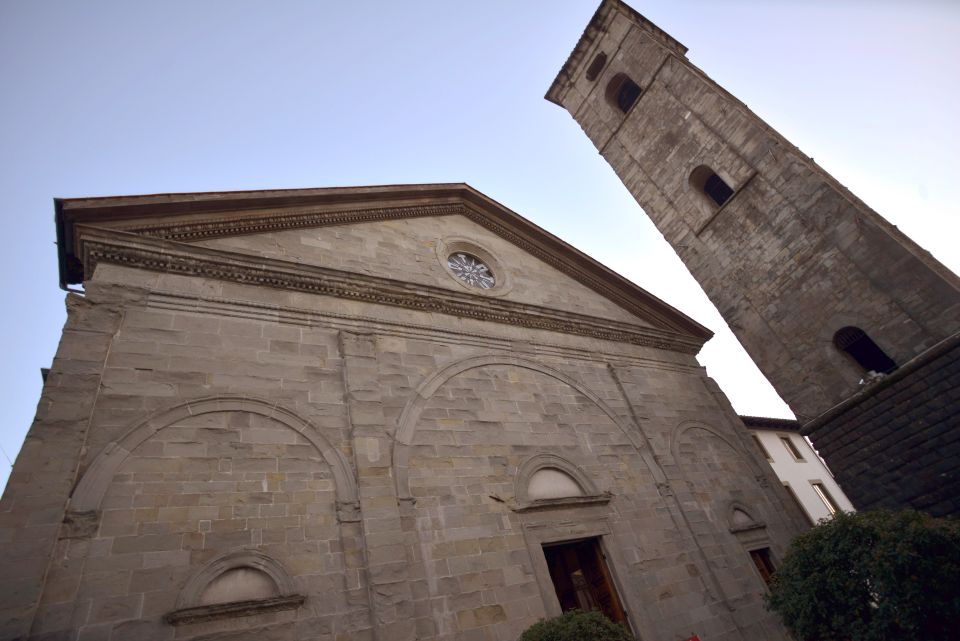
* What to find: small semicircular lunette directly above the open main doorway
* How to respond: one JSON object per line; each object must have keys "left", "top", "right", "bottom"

{"left": 516, "top": 454, "right": 610, "bottom": 511}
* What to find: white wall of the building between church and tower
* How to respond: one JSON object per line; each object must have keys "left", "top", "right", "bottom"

{"left": 750, "top": 429, "right": 854, "bottom": 524}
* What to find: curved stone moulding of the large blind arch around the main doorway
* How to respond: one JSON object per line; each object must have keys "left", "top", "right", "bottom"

{"left": 393, "top": 354, "right": 649, "bottom": 499}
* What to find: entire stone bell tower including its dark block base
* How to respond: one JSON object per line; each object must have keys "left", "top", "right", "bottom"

{"left": 546, "top": 0, "right": 960, "bottom": 515}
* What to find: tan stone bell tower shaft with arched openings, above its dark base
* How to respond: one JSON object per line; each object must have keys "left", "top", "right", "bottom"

{"left": 546, "top": 0, "right": 960, "bottom": 423}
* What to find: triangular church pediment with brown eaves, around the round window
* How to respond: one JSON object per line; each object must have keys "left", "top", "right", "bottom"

{"left": 57, "top": 184, "right": 711, "bottom": 352}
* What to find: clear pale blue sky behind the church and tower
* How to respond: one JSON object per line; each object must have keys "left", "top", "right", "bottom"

{"left": 0, "top": 0, "right": 960, "bottom": 484}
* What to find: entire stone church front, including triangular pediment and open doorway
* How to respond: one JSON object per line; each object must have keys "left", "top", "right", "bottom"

{"left": 0, "top": 185, "right": 805, "bottom": 641}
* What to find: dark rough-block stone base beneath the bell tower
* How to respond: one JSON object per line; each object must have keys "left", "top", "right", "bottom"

{"left": 804, "top": 336, "right": 960, "bottom": 516}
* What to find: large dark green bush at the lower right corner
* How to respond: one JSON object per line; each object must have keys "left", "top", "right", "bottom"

{"left": 767, "top": 510, "right": 960, "bottom": 641}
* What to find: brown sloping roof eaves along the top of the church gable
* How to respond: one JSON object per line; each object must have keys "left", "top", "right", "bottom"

{"left": 55, "top": 183, "right": 713, "bottom": 342}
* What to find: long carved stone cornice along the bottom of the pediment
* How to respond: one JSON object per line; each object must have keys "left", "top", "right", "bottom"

{"left": 77, "top": 227, "right": 702, "bottom": 354}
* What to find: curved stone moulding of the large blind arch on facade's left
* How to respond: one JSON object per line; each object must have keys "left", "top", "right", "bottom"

{"left": 70, "top": 396, "right": 358, "bottom": 512}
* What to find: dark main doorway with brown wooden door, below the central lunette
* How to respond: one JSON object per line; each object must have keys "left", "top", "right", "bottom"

{"left": 543, "top": 539, "right": 627, "bottom": 626}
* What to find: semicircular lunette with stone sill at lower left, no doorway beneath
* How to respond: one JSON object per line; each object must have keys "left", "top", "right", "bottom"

{"left": 165, "top": 550, "right": 306, "bottom": 625}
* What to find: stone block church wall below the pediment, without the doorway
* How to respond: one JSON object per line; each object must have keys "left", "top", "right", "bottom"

{"left": 0, "top": 218, "right": 801, "bottom": 641}
